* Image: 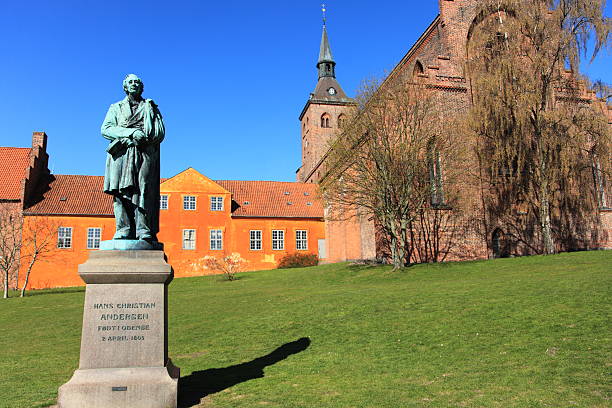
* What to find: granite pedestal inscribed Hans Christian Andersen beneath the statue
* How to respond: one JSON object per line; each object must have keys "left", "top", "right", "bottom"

{"left": 58, "top": 250, "right": 179, "bottom": 408}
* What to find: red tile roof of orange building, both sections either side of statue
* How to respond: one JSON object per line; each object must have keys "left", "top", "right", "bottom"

{"left": 25, "top": 174, "right": 323, "bottom": 218}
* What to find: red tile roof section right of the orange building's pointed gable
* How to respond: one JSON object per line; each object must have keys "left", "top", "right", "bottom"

{"left": 216, "top": 180, "right": 323, "bottom": 218}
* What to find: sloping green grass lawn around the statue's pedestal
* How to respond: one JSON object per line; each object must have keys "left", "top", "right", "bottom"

{"left": 0, "top": 252, "right": 612, "bottom": 408}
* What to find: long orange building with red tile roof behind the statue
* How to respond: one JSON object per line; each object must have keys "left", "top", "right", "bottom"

{"left": 13, "top": 155, "right": 325, "bottom": 289}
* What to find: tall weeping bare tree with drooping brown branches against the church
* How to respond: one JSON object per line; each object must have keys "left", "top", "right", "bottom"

{"left": 468, "top": 0, "right": 611, "bottom": 254}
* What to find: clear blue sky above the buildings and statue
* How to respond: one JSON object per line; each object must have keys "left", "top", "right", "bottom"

{"left": 0, "top": 0, "right": 612, "bottom": 181}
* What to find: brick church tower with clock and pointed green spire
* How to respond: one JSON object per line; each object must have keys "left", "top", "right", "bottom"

{"left": 297, "top": 18, "right": 355, "bottom": 183}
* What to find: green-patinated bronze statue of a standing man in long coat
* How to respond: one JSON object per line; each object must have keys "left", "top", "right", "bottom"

{"left": 102, "top": 74, "right": 165, "bottom": 242}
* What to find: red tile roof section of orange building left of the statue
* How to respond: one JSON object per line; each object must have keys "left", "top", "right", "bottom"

{"left": 25, "top": 174, "right": 113, "bottom": 216}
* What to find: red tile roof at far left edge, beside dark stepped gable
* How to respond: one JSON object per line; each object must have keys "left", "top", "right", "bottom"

{"left": 0, "top": 147, "right": 32, "bottom": 200}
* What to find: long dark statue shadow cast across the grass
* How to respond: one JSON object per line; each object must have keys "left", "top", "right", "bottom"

{"left": 178, "top": 337, "right": 310, "bottom": 408}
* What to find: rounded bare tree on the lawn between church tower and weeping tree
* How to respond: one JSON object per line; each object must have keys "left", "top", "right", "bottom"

{"left": 321, "top": 78, "right": 461, "bottom": 269}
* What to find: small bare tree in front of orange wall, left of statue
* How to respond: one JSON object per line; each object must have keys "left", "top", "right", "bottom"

{"left": 20, "top": 217, "right": 58, "bottom": 297}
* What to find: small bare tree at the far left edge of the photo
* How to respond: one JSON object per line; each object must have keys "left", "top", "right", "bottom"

{"left": 0, "top": 205, "right": 22, "bottom": 299}
